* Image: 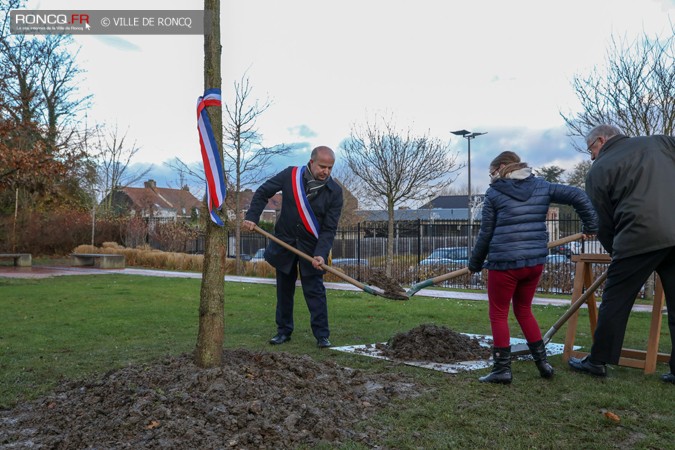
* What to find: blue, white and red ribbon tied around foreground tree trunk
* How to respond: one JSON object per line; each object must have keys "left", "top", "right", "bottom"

{"left": 197, "top": 89, "right": 226, "bottom": 227}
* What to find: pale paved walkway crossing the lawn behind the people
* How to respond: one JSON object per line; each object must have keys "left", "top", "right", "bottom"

{"left": 0, "top": 266, "right": 666, "bottom": 314}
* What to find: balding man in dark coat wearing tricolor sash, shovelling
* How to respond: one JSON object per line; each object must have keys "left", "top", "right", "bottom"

{"left": 242, "top": 146, "right": 342, "bottom": 348}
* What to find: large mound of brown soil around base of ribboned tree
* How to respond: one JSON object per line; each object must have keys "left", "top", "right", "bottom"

{"left": 0, "top": 348, "right": 426, "bottom": 449}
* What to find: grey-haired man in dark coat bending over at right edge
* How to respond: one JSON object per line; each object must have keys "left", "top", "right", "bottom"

{"left": 569, "top": 125, "right": 675, "bottom": 383}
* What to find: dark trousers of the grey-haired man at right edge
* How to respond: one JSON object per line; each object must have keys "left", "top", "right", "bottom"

{"left": 591, "top": 247, "right": 675, "bottom": 373}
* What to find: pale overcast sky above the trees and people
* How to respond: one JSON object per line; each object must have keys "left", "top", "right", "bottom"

{"left": 27, "top": 0, "right": 675, "bottom": 200}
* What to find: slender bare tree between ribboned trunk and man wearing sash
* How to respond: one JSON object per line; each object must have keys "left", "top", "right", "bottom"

{"left": 223, "top": 77, "right": 290, "bottom": 274}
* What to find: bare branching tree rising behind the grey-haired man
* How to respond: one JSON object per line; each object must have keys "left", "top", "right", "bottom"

{"left": 561, "top": 29, "right": 675, "bottom": 154}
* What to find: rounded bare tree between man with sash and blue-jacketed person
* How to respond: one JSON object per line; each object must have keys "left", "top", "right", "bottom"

{"left": 341, "top": 116, "right": 461, "bottom": 276}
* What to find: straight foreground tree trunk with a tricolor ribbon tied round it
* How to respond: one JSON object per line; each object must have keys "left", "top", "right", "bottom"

{"left": 195, "top": 0, "right": 227, "bottom": 368}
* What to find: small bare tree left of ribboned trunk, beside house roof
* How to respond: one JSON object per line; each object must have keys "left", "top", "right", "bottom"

{"left": 94, "top": 124, "right": 152, "bottom": 212}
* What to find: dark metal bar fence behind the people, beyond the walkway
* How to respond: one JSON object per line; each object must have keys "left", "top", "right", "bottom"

{"left": 220, "top": 218, "right": 604, "bottom": 294}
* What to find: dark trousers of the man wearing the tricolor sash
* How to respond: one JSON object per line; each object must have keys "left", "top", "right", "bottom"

{"left": 276, "top": 263, "right": 330, "bottom": 339}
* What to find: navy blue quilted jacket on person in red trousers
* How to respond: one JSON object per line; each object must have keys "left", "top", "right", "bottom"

{"left": 469, "top": 175, "right": 598, "bottom": 272}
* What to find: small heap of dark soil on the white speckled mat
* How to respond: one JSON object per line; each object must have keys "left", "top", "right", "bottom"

{"left": 376, "top": 324, "right": 491, "bottom": 363}
